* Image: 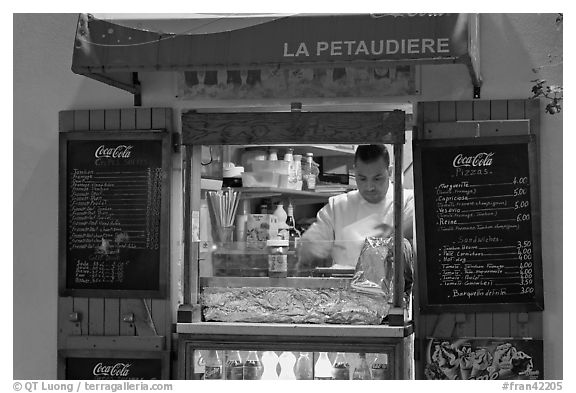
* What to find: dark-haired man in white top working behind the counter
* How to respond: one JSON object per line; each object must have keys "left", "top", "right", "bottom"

{"left": 298, "top": 145, "right": 414, "bottom": 270}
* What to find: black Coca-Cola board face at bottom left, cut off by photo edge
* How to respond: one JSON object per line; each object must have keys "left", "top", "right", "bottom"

{"left": 60, "top": 350, "right": 169, "bottom": 380}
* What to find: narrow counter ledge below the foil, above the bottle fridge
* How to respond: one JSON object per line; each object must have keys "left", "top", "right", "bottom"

{"left": 176, "top": 322, "right": 414, "bottom": 338}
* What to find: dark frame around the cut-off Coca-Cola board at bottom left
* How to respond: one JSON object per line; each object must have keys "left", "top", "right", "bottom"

{"left": 58, "top": 349, "right": 170, "bottom": 380}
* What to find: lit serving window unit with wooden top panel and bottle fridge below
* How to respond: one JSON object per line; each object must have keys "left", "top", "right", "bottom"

{"left": 177, "top": 111, "right": 413, "bottom": 379}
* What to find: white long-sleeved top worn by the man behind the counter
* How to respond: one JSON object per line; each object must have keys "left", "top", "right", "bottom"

{"left": 302, "top": 184, "right": 414, "bottom": 267}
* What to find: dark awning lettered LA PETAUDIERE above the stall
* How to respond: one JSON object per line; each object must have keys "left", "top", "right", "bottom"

{"left": 72, "top": 14, "right": 482, "bottom": 97}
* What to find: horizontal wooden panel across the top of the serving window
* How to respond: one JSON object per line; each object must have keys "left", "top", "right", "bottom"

{"left": 182, "top": 111, "right": 405, "bottom": 145}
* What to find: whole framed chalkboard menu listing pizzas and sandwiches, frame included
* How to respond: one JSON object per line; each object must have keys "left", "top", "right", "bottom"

{"left": 414, "top": 135, "right": 543, "bottom": 311}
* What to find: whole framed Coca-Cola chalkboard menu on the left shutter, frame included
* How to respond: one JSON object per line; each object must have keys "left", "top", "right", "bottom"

{"left": 60, "top": 131, "right": 170, "bottom": 297}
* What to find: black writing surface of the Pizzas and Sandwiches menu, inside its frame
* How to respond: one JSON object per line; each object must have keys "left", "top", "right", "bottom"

{"left": 423, "top": 144, "right": 535, "bottom": 304}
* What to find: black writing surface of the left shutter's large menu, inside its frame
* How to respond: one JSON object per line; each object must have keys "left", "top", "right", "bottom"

{"left": 67, "top": 141, "right": 163, "bottom": 289}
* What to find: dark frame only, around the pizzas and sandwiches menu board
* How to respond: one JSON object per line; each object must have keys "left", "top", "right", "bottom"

{"left": 414, "top": 135, "right": 544, "bottom": 313}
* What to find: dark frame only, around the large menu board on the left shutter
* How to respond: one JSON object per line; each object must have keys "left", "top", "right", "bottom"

{"left": 58, "top": 130, "right": 172, "bottom": 298}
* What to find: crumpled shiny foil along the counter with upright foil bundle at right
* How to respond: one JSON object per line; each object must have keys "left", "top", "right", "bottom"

{"left": 200, "top": 234, "right": 413, "bottom": 325}
